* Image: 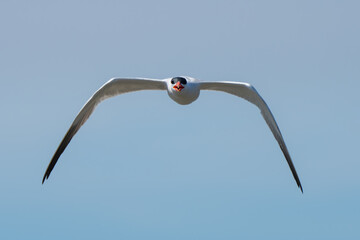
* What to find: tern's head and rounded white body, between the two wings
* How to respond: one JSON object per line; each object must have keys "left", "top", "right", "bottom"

{"left": 167, "top": 77, "right": 200, "bottom": 105}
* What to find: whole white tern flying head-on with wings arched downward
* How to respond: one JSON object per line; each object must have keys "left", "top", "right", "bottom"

{"left": 42, "top": 76, "right": 303, "bottom": 192}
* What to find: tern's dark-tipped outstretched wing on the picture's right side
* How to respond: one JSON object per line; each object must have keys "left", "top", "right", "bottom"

{"left": 200, "top": 82, "right": 303, "bottom": 192}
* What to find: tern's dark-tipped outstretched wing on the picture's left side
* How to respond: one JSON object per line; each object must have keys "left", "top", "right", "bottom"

{"left": 42, "top": 78, "right": 166, "bottom": 183}
